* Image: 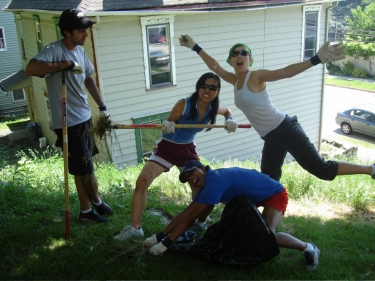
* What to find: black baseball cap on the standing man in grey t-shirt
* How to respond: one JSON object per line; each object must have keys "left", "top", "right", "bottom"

{"left": 59, "top": 9, "right": 96, "bottom": 30}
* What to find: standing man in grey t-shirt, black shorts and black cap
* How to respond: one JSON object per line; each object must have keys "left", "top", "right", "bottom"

{"left": 26, "top": 9, "right": 113, "bottom": 222}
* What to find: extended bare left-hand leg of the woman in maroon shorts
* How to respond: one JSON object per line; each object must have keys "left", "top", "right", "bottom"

{"left": 132, "top": 161, "right": 165, "bottom": 229}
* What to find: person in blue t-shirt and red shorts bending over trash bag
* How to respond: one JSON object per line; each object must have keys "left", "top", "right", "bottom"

{"left": 144, "top": 160, "right": 320, "bottom": 270}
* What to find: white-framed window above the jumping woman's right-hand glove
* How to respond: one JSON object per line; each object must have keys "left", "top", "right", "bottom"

{"left": 302, "top": 6, "right": 322, "bottom": 61}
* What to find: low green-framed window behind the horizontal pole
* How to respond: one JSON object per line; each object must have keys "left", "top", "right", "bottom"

{"left": 132, "top": 111, "right": 170, "bottom": 163}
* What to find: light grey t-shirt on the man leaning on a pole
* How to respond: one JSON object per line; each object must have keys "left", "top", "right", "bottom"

{"left": 34, "top": 40, "right": 94, "bottom": 129}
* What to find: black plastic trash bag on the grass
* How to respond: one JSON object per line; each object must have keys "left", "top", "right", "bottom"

{"left": 171, "top": 195, "right": 280, "bottom": 266}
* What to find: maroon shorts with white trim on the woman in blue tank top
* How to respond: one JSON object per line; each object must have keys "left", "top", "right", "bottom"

{"left": 148, "top": 139, "right": 199, "bottom": 172}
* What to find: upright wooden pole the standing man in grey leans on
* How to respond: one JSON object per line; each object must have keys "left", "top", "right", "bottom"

{"left": 61, "top": 70, "right": 70, "bottom": 238}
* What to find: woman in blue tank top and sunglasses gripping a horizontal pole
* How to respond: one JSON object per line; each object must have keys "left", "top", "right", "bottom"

{"left": 114, "top": 72, "right": 237, "bottom": 240}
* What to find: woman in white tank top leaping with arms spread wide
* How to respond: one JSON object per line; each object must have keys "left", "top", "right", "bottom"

{"left": 180, "top": 35, "right": 375, "bottom": 181}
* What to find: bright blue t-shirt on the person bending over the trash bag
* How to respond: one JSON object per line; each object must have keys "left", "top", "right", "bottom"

{"left": 193, "top": 167, "right": 284, "bottom": 204}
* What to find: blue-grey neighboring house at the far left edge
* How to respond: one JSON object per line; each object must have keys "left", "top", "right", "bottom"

{"left": 0, "top": 0, "right": 28, "bottom": 117}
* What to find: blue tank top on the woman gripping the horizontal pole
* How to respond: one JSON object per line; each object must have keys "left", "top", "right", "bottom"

{"left": 161, "top": 97, "right": 212, "bottom": 143}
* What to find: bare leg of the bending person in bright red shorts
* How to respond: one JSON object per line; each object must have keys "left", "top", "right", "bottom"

{"left": 262, "top": 207, "right": 307, "bottom": 251}
